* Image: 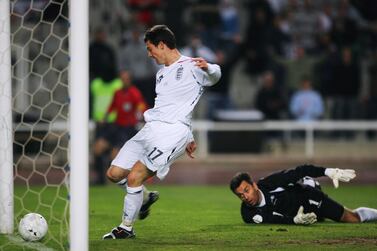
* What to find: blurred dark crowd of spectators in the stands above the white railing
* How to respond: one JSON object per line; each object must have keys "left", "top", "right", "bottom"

{"left": 90, "top": 0, "right": 377, "bottom": 125}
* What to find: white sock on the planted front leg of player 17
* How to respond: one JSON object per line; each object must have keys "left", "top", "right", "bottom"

{"left": 122, "top": 186, "right": 143, "bottom": 227}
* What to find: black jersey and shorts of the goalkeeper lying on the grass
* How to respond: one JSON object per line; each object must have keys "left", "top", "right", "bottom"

{"left": 241, "top": 165, "right": 344, "bottom": 224}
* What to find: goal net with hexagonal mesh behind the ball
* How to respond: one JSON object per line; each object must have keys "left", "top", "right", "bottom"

{"left": 0, "top": 0, "right": 87, "bottom": 250}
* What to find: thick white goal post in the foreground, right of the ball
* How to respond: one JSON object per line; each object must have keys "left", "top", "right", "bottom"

{"left": 69, "top": 0, "right": 89, "bottom": 251}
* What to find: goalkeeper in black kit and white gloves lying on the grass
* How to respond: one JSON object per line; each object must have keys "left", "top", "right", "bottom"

{"left": 230, "top": 165, "right": 377, "bottom": 225}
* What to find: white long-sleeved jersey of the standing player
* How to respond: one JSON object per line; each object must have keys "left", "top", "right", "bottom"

{"left": 144, "top": 56, "right": 221, "bottom": 125}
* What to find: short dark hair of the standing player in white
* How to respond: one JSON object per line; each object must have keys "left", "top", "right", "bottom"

{"left": 144, "top": 24, "right": 177, "bottom": 49}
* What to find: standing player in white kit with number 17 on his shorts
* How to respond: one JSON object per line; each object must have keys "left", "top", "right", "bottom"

{"left": 103, "top": 25, "right": 221, "bottom": 239}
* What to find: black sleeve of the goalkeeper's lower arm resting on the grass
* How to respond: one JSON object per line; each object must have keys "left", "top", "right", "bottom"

{"left": 241, "top": 203, "right": 294, "bottom": 224}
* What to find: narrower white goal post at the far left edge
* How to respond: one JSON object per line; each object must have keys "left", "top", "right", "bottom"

{"left": 0, "top": 0, "right": 14, "bottom": 234}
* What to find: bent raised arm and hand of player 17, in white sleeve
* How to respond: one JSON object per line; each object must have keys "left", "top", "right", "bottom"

{"left": 192, "top": 58, "right": 221, "bottom": 86}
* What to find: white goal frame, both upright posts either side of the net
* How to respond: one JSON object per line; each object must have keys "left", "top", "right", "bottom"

{"left": 0, "top": 0, "right": 89, "bottom": 251}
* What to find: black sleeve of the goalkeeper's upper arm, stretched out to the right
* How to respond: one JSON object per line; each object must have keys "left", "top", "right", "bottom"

{"left": 258, "top": 165, "right": 325, "bottom": 189}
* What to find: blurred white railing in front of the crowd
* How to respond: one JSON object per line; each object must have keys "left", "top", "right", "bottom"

{"left": 13, "top": 120, "right": 377, "bottom": 158}
